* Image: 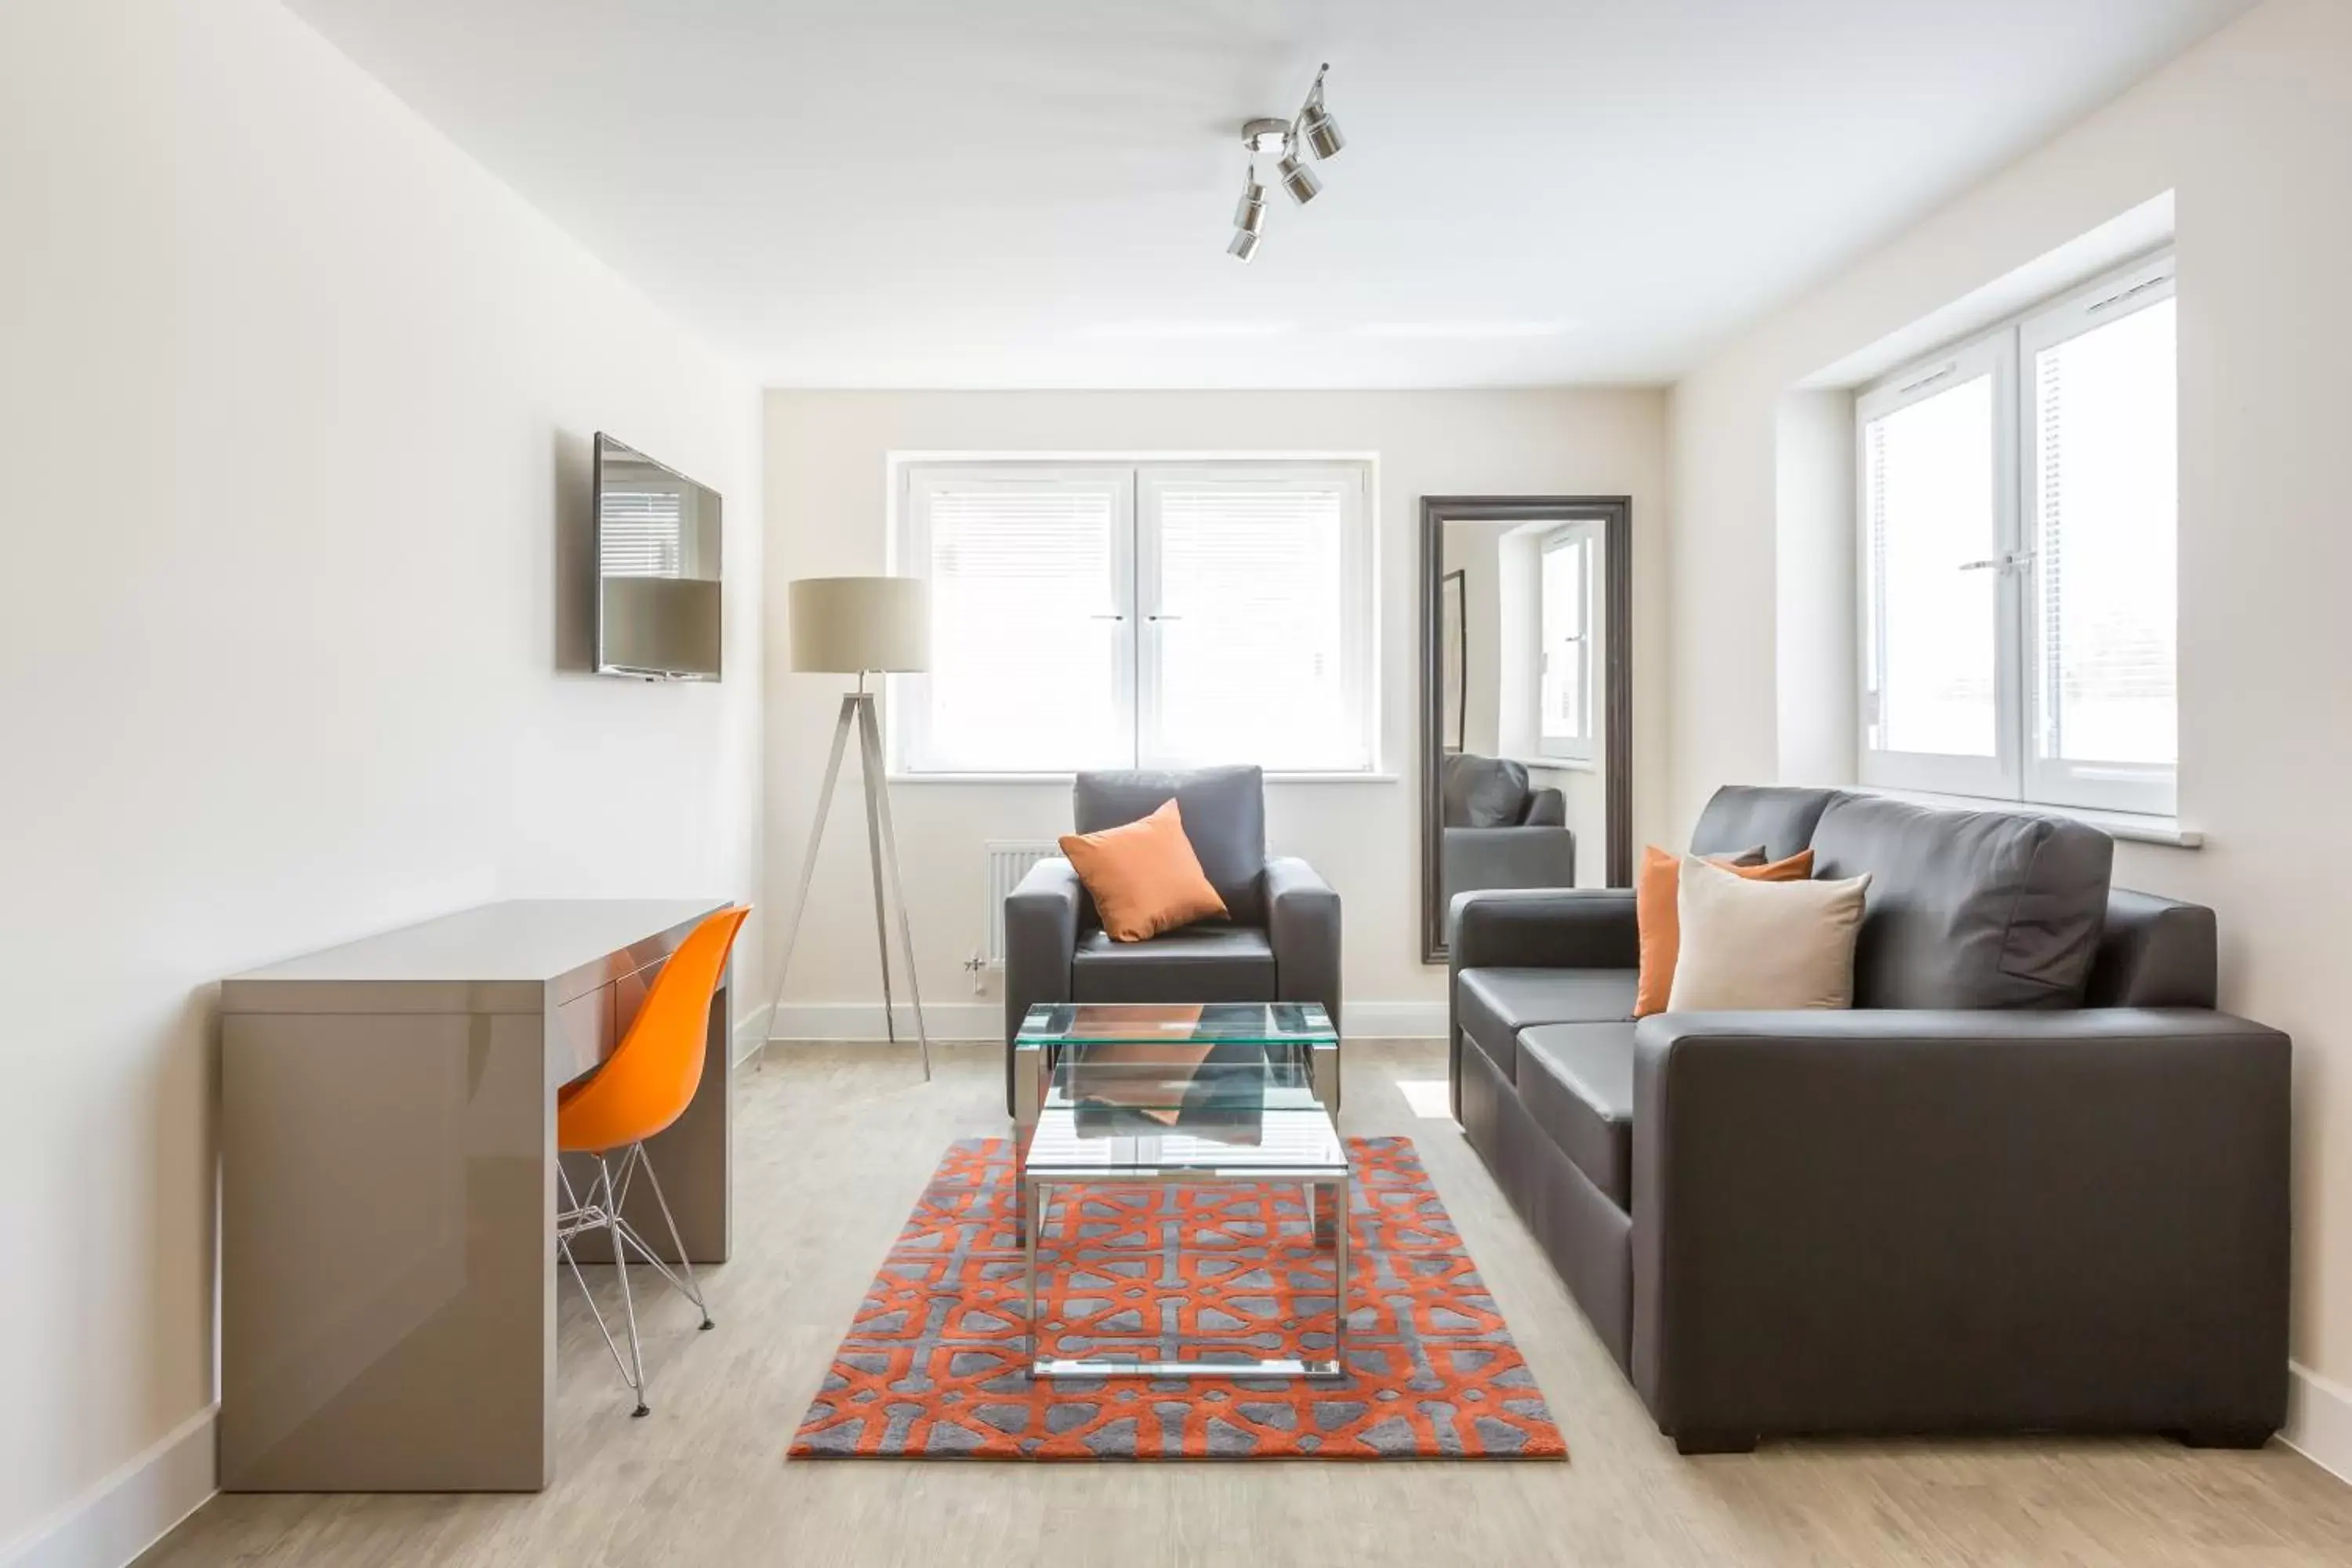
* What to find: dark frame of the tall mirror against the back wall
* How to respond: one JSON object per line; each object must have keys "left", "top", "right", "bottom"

{"left": 1418, "top": 496, "right": 1632, "bottom": 964}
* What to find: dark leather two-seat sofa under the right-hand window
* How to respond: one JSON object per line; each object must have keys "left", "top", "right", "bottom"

{"left": 1451, "top": 787, "right": 2288, "bottom": 1453}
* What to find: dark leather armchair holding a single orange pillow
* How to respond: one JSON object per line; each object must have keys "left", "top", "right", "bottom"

{"left": 1004, "top": 767, "right": 1338, "bottom": 1112}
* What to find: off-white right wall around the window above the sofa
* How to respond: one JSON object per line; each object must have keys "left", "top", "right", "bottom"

{"left": 1668, "top": 0, "right": 2352, "bottom": 1467}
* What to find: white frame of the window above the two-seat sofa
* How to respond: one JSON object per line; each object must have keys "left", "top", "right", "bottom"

{"left": 1853, "top": 249, "right": 2178, "bottom": 815}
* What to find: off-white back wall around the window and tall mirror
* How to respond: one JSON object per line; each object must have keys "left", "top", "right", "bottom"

{"left": 767, "top": 390, "right": 1665, "bottom": 1032}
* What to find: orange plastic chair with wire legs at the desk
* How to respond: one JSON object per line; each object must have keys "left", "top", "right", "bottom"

{"left": 555, "top": 905, "right": 750, "bottom": 1415}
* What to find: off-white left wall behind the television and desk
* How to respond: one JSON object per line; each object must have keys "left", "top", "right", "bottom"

{"left": 0, "top": 0, "right": 762, "bottom": 1561}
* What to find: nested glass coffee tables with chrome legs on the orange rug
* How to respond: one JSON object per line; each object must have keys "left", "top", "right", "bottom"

{"left": 1014, "top": 1001, "right": 1350, "bottom": 1377}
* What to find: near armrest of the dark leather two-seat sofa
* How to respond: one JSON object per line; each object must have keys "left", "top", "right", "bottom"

{"left": 1632, "top": 1008, "right": 2288, "bottom": 1446}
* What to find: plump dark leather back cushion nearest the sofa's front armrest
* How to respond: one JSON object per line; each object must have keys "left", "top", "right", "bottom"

{"left": 1813, "top": 794, "right": 2114, "bottom": 1008}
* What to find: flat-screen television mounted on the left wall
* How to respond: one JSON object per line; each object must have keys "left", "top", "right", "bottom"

{"left": 595, "top": 430, "right": 720, "bottom": 680}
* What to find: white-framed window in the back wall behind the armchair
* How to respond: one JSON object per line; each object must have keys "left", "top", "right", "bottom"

{"left": 891, "top": 461, "right": 1376, "bottom": 774}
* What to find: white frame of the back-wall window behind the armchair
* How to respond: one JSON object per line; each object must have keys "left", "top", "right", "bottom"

{"left": 887, "top": 454, "right": 1381, "bottom": 779}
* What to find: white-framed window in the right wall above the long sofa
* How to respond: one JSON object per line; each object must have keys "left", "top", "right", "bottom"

{"left": 1856, "top": 256, "right": 2178, "bottom": 815}
